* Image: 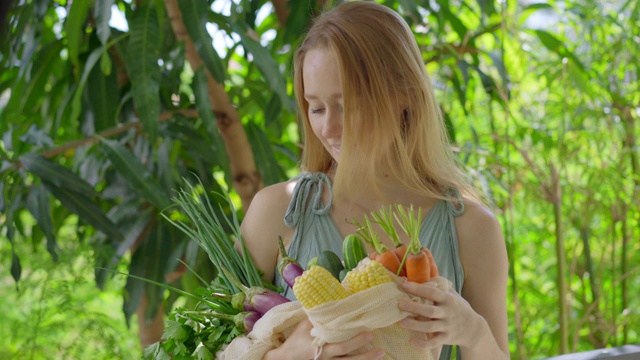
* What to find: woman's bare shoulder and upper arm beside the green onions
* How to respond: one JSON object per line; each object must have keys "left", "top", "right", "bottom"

{"left": 241, "top": 181, "right": 295, "bottom": 281}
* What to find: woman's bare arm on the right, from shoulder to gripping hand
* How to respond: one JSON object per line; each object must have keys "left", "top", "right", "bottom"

{"left": 399, "top": 203, "right": 510, "bottom": 360}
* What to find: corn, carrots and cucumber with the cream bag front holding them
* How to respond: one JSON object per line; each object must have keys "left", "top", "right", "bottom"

{"left": 281, "top": 205, "right": 451, "bottom": 360}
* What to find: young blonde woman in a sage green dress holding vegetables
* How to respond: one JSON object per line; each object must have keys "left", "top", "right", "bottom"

{"left": 242, "top": 2, "right": 509, "bottom": 360}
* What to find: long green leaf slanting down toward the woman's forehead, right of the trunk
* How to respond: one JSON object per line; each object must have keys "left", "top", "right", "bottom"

{"left": 233, "top": 23, "right": 295, "bottom": 111}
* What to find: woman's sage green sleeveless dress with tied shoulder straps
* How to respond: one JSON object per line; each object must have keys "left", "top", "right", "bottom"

{"left": 275, "top": 173, "right": 464, "bottom": 360}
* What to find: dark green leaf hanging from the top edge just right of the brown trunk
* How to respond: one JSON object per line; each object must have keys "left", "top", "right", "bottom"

{"left": 178, "top": 0, "right": 226, "bottom": 84}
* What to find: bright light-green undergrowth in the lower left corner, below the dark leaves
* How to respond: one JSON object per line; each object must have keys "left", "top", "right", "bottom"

{"left": 0, "top": 219, "right": 140, "bottom": 360}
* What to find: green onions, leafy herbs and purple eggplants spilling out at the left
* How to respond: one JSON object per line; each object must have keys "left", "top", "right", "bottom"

{"left": 142, "top": 183, "right": 289, "bottom": 359}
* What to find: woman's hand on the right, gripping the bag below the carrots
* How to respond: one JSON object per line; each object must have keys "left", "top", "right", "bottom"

{"left": 398, "top": 281, "right": 481, "bottom": 348}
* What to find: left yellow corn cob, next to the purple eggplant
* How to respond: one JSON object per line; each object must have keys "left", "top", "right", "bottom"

{"left": 293, "top": 265, "right": 349, "bottom": 309}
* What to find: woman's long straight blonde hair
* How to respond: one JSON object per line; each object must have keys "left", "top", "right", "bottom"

{"left": 294, "top": 1, "right": 478, "bottom": 199}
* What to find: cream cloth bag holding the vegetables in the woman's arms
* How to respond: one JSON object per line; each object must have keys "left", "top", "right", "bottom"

{"left": 216, "top": 275, "right": 451, "bottom": 360}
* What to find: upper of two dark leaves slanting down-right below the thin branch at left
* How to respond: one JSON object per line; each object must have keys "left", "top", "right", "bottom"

{"left": 20, "top": 153, "right": 98, "bottom": 197}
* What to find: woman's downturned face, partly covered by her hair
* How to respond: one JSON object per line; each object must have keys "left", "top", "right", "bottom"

{"left": 302, "top": 49, "right": 343, "bottom": 162}
